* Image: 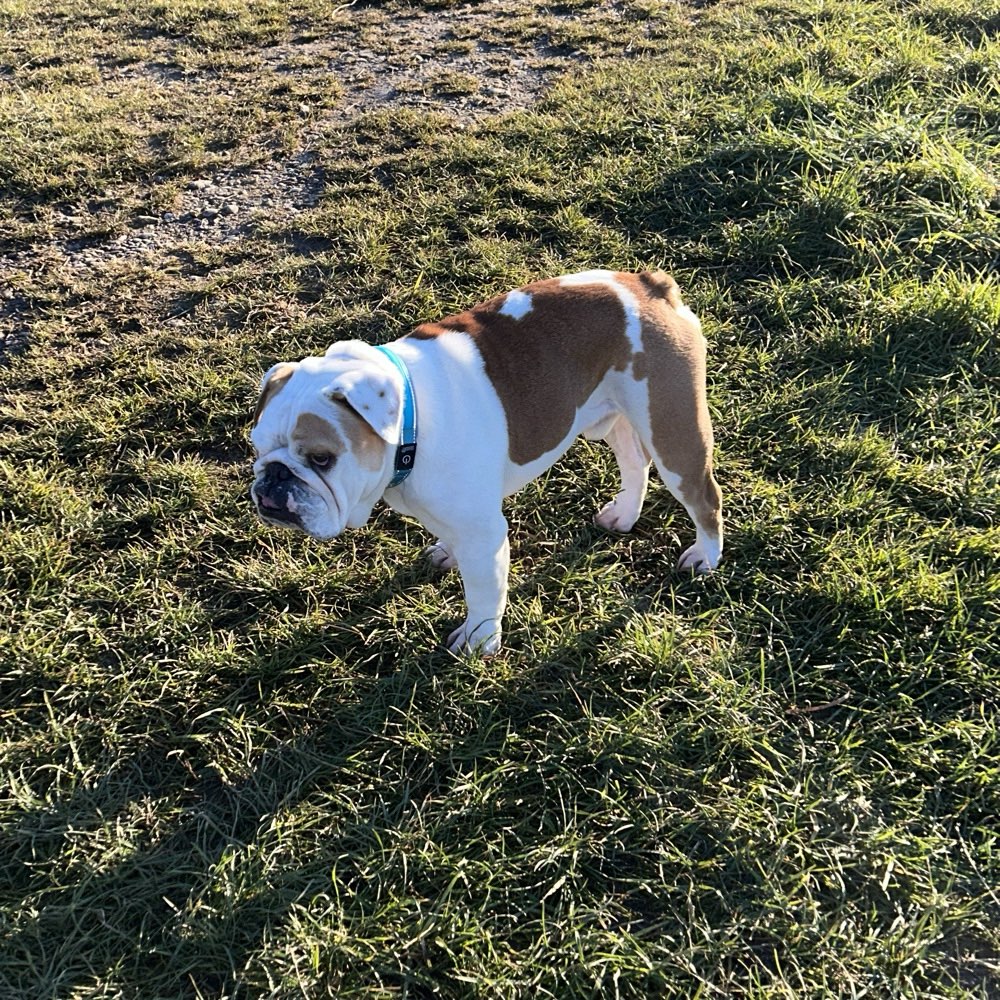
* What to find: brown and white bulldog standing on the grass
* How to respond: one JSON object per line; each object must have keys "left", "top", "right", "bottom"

{"left": 251, "top": 271, "right": 722, "bottom": 654}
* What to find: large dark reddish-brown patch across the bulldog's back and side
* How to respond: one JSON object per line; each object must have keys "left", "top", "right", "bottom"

{"left": 410, "top": 279, "right": 632, "bottom": 465}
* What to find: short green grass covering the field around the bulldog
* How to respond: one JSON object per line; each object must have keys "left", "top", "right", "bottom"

{"left": 0, "top": 0, "right": 1000, "bottom": 1000}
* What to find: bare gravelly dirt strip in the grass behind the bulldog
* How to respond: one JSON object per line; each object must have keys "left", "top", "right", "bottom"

{"left": 0, "top": 2, "right": 664, "bottom": 359}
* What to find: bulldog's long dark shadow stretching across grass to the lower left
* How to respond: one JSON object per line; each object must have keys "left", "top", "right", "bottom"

{"left": 2, "top": 490, "right": 740, "bottom": 995}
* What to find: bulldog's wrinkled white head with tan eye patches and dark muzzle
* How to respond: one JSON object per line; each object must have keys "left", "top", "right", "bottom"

{"left": 250, "top": 341, "right": 401, "bottom": 538}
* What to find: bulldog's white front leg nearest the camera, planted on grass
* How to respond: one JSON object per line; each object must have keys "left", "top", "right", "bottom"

{"left": 448, "top": 516, "right": 510, "bottom": 656}
